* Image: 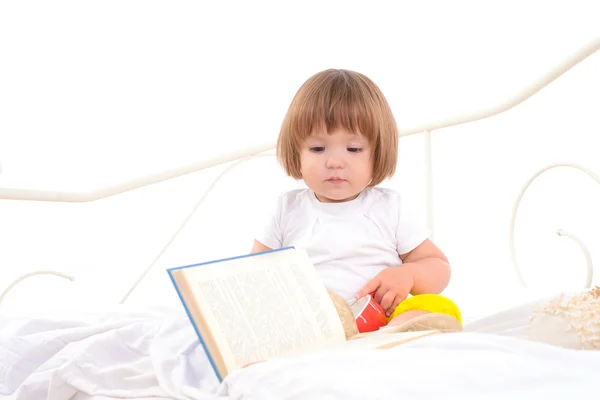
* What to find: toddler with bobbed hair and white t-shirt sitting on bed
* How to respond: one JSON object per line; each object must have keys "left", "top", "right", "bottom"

{"left": 252, "top": 69, "right": 462, "bottom": 331}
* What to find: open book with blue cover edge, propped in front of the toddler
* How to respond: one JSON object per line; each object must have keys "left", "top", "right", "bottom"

{"left": 168, "top": 247, "right": 435, "bottom": 380}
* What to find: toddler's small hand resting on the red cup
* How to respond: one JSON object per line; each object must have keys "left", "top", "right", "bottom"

{"left": 356, "top": 266, "right": 415, "bottom": 317}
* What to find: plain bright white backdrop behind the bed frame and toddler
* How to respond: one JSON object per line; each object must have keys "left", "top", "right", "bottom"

{"left": 0, "top": 0, "right": 600, "bottom": 314}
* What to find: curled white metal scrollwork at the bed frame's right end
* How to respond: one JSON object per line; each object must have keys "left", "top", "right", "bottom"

{"left": 509, "top": 163, "right": 600, "bottom": 287}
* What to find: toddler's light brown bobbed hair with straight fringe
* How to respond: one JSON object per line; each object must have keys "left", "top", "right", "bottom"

{"left": 277, "top": 69, "right": 398, "bottom": 186}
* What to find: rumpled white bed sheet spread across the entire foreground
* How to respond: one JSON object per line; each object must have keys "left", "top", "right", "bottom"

{"left": 0, "top": 304, "right": 600, "bottom": 400}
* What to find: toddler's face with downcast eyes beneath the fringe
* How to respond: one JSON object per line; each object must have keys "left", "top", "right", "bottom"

{"left": 300, "top": 128, "right": 373, "bottom": 203}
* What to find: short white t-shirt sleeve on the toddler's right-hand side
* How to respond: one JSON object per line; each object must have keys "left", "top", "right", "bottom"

{"left": 396, "top": 190, "right": 430, "bottom": 254}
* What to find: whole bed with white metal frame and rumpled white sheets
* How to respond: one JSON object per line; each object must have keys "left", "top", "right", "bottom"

{"left": 0, "top": 38, "right": 600, "bottom": 400}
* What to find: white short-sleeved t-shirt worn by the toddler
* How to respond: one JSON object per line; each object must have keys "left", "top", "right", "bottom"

{"left": 256, "top": 187, "right": 428, "bottom": 300}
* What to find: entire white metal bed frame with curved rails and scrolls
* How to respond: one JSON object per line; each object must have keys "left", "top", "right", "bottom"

{"left": 0, "top": 37, "right": 600, "bottom": 305}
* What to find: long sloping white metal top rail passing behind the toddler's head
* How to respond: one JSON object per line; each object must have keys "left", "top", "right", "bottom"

{"left": 0, "top": 37, "right": 600, "bottom": 203}
